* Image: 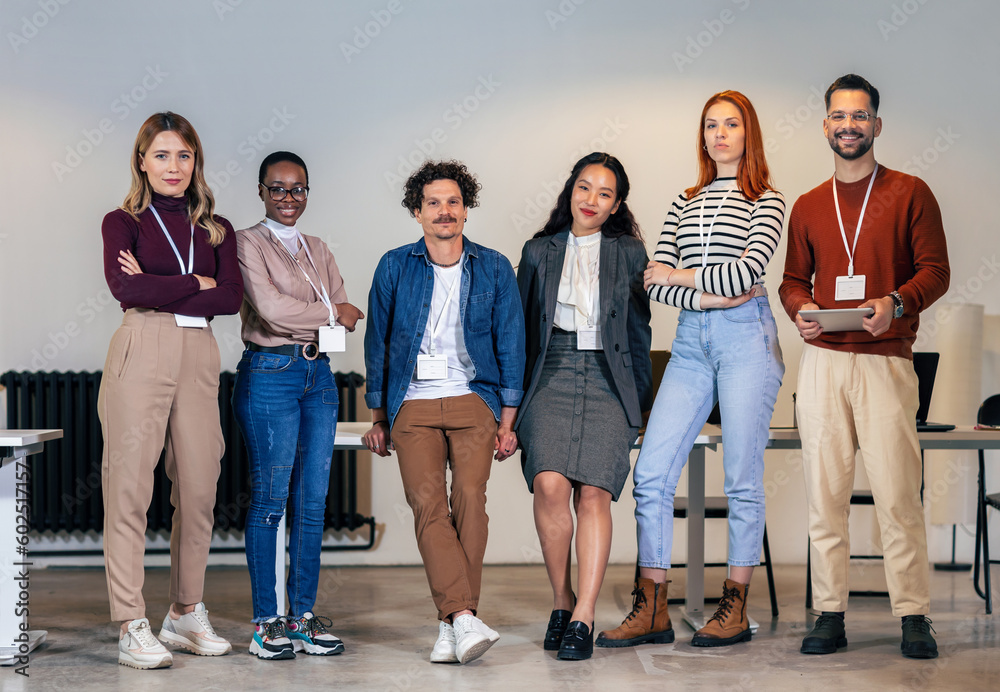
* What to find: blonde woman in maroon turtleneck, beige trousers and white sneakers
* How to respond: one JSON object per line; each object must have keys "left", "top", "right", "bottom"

{"left": 98, "top": 112, "right": 243, "bottom": 669}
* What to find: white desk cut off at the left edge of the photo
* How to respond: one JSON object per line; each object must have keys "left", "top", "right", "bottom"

{"left": 0, "top": 430, "right": 62, "bottom": 666}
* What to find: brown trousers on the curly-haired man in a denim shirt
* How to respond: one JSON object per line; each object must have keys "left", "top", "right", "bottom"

{"left": 392, "top": 394, "right": 497, "bottom": 621}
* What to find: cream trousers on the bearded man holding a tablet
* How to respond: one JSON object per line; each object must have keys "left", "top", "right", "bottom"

{"left": 796, "top": 343, "right": 930, "bottom": 617}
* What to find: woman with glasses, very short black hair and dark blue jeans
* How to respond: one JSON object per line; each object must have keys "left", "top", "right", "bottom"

{"left": 233, "top": 151, "right": 364, "bottom": 660}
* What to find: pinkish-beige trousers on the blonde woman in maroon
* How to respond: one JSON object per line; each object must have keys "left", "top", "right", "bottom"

{"left": 98, "top": 308, "right": 225, "bottom": 620}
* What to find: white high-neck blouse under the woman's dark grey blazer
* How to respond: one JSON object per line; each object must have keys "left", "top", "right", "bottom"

{"left": 552, "top": 231, "right": 601, "bottom": 332}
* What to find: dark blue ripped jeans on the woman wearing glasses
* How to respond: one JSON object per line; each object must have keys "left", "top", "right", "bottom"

{"left": 233, "top": 351, "right": 339, "bottom": 623}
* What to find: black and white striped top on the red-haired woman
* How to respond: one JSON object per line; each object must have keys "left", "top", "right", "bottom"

{"left": 649, "top": 178, "right": 785, "bottom": 310}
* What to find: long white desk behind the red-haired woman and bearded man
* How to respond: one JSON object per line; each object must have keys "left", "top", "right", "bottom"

{"left": 681, "top": 425, "right": 1000, "bottom": 630}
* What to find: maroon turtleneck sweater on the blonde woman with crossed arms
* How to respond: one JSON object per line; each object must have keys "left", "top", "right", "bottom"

{"left": 101, "top": 192, "right": 243, "bottom": 317}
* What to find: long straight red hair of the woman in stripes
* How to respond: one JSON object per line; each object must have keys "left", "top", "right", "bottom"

{"left": 684, "top": 90, "right": 773, "bottom": 202}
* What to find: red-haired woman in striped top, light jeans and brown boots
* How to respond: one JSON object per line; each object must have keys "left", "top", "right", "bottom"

{"left": 597, "top": 91, "right": 785, "bottom": 647}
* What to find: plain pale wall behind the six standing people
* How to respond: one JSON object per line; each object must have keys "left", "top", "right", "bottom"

{"left": 0, "top": 0, "right": 1000, "bottom": 563}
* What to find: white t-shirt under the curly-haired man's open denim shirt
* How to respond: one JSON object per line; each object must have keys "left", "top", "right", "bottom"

{"left": 403, "top": 255, "right": 476, "bottom": 401}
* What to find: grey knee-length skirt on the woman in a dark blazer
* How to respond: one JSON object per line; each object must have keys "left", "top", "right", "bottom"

{"left": 518, "top": 329, "right": 639, "bottom": 501}
